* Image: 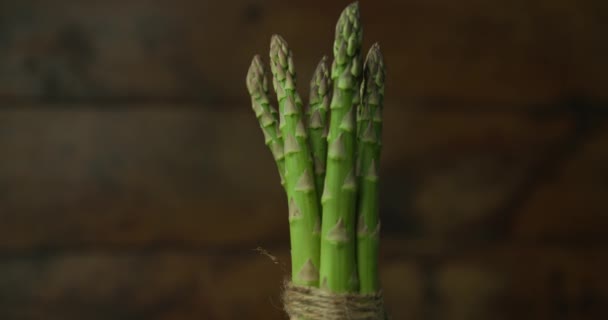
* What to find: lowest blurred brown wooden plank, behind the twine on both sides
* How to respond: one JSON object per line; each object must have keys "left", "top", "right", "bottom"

{"left": 0, "top": 244, "right": 608, "bottom": 320}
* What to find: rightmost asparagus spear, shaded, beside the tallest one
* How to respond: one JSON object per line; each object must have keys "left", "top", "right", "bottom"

{"left": 357, "top": 43, "right": 384, "bottom": 294}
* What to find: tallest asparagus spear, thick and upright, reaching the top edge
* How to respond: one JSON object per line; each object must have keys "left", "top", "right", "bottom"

{"left": 320, "top": 3, "right": 362, "bottom": 292}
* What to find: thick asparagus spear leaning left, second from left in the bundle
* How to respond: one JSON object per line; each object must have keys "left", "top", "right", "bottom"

{"left": 270, "top": 35, "right": 320, "bottom": 287}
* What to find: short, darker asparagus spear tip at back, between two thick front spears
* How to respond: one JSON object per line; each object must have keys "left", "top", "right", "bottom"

{"left": 308, "top": 56, "right": 331, "bottom": 199}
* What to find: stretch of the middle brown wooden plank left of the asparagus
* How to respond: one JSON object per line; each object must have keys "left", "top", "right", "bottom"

{"left": 0, "top": 108, "right": 288, "bottom": 248}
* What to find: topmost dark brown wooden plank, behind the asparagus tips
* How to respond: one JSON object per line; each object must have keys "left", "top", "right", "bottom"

{"left": 0, "top": 0, "right": 608, "bottom": 107}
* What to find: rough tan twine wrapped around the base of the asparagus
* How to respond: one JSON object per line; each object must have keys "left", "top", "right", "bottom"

{"left": 283, "top": 282, "right": 385, "bottom": 320}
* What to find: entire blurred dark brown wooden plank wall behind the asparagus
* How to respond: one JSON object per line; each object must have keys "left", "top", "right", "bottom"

{"left": 0, "top": 0, "right": 608, "bottom": 320}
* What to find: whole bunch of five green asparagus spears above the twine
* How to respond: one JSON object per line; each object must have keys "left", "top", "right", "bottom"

{"left": 247, "top": 3, "right": 384, "bottom": 320}
